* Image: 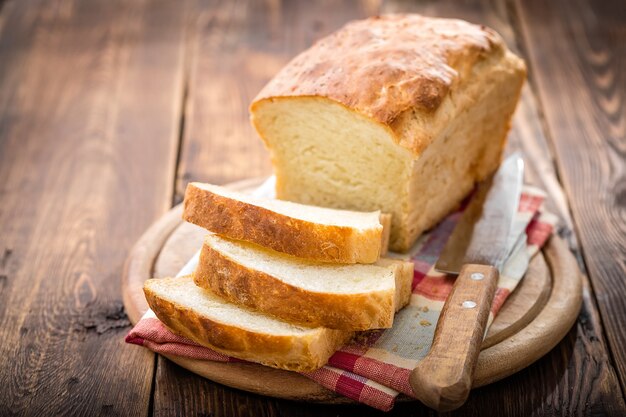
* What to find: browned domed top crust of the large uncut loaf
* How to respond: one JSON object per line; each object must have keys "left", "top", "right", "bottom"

{"left": 253, "top": 14, "right": 505, "bottom": 125}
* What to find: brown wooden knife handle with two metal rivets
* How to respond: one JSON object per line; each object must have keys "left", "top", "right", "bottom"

{"left": 409, "top": 264, "right": 498, "bottom": 411}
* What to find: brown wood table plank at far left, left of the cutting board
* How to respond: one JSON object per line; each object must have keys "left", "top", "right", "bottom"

{"left": 0, "top": 0, "right": 184, "bottom": 415}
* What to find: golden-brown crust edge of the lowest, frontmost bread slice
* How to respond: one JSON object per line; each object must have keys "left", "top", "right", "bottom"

{"left": 144, "top": 278, "right": 352, "bottom": 372}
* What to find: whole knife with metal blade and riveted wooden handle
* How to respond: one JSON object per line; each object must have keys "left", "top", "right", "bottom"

{"left": 409, "top": 154, "right": 524, "bottom": 411}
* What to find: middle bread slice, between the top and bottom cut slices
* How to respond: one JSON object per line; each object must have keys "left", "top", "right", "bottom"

{"left": 194, "top": 234, "right": 413, "bottom": 330}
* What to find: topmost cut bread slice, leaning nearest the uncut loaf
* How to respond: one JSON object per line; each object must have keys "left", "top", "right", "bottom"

{"left": 183, "top": 183, "right": 391, "bottom": 263}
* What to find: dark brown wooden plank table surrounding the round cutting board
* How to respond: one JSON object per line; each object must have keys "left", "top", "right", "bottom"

{"left": 0, "top": 0, "right": 626, "bottom": 416}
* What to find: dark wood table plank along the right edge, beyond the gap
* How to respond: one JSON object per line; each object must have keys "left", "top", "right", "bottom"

{"left": 515, "top": 0, "right": 626, "bottom": 389}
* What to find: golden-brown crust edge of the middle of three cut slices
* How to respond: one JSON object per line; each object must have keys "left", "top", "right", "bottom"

{"left": 194, "top": 243, "right": 404, "bottom": 331}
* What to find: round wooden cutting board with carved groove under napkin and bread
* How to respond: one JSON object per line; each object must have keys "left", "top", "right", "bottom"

{"left": 122, "top": 179, "right": 582, "bottom": 403}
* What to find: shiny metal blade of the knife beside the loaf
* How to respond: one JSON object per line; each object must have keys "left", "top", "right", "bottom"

{"left": 435, "top": 153, "right": 524, "bottom": 274}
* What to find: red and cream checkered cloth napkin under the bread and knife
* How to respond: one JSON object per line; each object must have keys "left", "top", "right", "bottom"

{"left": 126, "top": 180, "right": 556, "bottom": 411}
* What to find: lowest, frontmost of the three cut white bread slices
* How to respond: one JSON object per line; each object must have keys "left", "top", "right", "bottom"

{"left": 144, "top": 276, "right": 353, "bottom": 372}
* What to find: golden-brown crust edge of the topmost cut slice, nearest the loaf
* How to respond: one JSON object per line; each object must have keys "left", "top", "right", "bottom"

{"left": 183, "top": 183, "right": 383, "bottom": 263}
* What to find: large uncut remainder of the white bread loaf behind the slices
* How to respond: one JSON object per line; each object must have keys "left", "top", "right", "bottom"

{"left": 251, "top": 15, "right": 526, "bottom": 251}
